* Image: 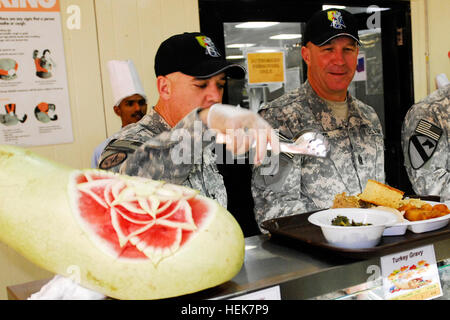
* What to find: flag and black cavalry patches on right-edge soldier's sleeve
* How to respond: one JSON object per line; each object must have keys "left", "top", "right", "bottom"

{"left": 408, "top": 119, "right": 442, "bottom": 170}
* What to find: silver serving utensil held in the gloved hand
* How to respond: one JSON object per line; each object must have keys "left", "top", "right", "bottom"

{"left": 216, "top": 130, "right": 330, "bottom": 158}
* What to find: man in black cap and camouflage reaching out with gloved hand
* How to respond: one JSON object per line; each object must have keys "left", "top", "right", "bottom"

{"left": 99, "top": 33, "right": 271, "bottom": 207}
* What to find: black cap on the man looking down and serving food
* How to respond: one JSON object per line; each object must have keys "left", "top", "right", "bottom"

{"left": 155, "top": 32, "right": 245, "bottom": 79}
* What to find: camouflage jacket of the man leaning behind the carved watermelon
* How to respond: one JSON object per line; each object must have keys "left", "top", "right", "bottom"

{"left": 99, "top": 104, "right": 227, "bottom": 207}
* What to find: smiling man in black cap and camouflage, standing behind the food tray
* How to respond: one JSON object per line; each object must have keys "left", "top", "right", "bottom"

{"left": 252, "top": 9, "right": 385, "bottom": 231}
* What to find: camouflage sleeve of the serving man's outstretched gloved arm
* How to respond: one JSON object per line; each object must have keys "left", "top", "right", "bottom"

{"left": 102, "top": 109, "right": 211, "bottom": 184}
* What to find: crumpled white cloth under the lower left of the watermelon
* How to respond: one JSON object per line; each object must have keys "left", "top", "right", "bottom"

{"left": 28, "top": 275, "right": 106, "bottom": 300}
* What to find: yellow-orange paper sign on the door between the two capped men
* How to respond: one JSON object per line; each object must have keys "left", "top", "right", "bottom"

{"left": 246, "top": 51, "right": 285, "bottom": 85}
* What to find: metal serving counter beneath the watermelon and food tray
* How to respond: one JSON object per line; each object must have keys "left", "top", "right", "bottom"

{"left": 6, "top": 235, "right": 450, "bottom": 300}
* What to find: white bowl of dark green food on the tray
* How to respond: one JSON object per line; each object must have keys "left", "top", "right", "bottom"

{"left": 308, "top": 208, "right": 398, "bottom": 249}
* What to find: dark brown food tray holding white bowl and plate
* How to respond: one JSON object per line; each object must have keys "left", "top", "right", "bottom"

{"left": 261, "top": 210, "right": 450, "bottom": 259}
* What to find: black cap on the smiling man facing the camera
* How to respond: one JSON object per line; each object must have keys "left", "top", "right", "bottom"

{"left": 303, "top": 8, "right": 361, "bottom": 47}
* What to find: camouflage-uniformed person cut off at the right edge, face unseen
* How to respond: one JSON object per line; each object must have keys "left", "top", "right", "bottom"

{"left": 402, "top": 84, "right": 450, "bottom": 201}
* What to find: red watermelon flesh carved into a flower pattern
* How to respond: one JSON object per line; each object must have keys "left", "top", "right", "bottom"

{"left": 70, "top": 171, "right": 212, "bottom": 264}
